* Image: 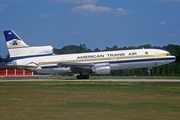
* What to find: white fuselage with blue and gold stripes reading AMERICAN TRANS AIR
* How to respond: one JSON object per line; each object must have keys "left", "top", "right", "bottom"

{"left": 7, "top": 49, "right": 176, "bottom": 73}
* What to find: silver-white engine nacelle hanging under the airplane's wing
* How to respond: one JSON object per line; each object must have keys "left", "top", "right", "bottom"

{"left": 93, "top": 66, "right": 110, "bottom": 75}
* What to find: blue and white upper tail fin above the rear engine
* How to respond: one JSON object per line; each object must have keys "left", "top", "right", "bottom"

{"left": 4, "top": 30, "right": 28, "bottom": 49}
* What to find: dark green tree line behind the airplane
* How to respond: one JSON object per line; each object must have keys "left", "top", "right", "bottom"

{"left": 0, "top": 44, "right": 180, "bottom": 76}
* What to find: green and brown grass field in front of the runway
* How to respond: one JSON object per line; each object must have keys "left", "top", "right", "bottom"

{"left": 0, "top": 81, "right": 180, "bottom": 120}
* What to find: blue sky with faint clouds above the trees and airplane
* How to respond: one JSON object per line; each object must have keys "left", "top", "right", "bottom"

{"left": 0, "top": 0, "right": 180, "bottom": 57}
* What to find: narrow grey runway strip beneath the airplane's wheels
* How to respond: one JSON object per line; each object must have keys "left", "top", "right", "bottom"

{"left": 0, "top": 79, "right": 180, "bottom": 82}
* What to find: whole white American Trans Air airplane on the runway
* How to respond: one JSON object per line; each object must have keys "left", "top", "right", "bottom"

{"left": 4, "top": 30, "right": 176, "bottom": 79}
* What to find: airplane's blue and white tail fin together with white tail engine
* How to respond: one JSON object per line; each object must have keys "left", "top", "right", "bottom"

{"left": 4, "top": 30, "right": 53, "bottom": 58}
